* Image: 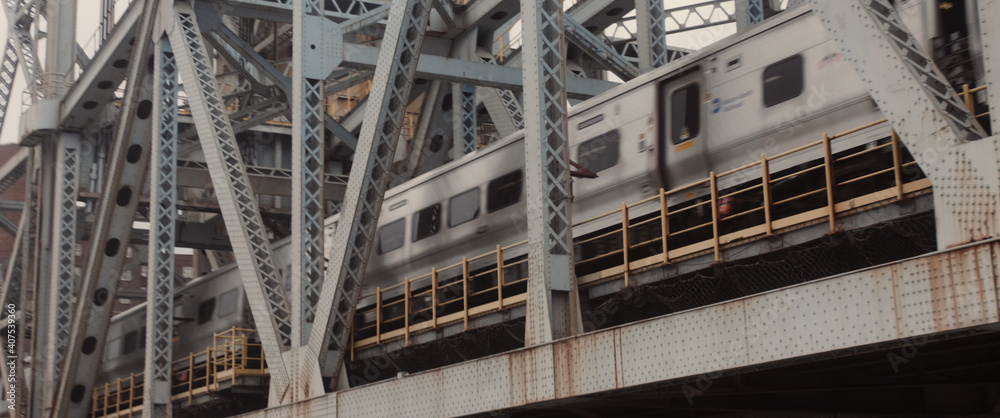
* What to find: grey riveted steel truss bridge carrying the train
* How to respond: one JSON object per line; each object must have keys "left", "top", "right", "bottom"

{"left": 0, "top": 0, "right": 1000, "bottom": 417}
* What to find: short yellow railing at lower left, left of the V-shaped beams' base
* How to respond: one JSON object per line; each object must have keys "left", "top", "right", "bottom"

{"left": 91, "top": 327, "right": 267, "bottom": 417}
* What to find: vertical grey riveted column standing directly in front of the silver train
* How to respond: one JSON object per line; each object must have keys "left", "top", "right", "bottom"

{"left": 521, "top": 0, "right": 580, "bottom": 347}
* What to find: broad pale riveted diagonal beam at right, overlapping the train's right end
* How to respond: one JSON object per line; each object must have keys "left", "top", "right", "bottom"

{"left": 810, "top": 0, "right": 1000, "bottom": 248}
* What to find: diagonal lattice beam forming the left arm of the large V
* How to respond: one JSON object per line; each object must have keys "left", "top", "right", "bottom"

{"left": 161, "top": 2, "right": 292, "bottom": 402}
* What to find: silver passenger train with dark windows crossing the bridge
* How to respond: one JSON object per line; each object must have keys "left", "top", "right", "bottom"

{"left": 99, "top": 1, "right": 956, "bottom": 388}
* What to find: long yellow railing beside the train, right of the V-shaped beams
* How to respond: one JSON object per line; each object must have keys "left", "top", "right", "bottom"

{"left": 352, "top": 81, "right": 985, "bottom": 346}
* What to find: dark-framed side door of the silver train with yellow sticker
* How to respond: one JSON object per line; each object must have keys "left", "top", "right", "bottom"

{"left": 658, "top": 68, "right": 708, "bottom": 196}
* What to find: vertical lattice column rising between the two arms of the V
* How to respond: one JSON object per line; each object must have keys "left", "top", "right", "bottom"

{"left": 289, "top": 0, "right": 340, "bottom": 400}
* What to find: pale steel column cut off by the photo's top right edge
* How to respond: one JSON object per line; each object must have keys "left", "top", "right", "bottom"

{"left": 972, "top": 0, "right": 1000, "bottom": 131}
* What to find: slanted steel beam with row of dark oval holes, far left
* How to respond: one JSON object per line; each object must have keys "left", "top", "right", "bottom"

{"left": 53, "top": 0, "right": 156, "bottom": 412}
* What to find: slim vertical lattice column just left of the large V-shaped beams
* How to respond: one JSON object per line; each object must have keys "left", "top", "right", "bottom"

{"left": 142, "top": 37, "right": 177, "bottom": 418}
